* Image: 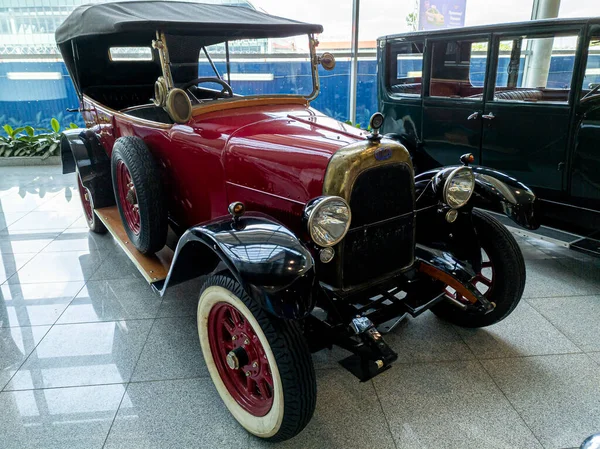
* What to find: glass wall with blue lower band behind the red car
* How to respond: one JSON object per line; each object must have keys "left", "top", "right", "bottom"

{"left": 0, "top": 0, "right": 377, "bottom": 128}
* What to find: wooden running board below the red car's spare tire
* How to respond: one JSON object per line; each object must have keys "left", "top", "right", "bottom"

{"left": 94, "top": 206, "right": 173, "bottom": 284}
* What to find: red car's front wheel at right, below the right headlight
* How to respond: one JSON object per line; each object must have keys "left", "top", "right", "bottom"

{"left": 431, "top": 210, "right": 526, "bottom": 327}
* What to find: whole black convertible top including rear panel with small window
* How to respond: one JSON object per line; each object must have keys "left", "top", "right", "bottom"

{"left": 56, "top": 1, "right": 323, "bottom": 96}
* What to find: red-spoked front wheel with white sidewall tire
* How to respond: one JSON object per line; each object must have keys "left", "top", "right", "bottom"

{"left": 198, "top": 276, "right": 317, "bottom": 441}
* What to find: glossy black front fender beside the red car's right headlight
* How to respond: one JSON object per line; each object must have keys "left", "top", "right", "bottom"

{"left": 415, "top": 166, "right": 540, "bottom": 229}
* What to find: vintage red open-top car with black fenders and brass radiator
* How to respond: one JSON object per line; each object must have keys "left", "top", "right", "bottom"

{"left": 56, "top": 1, "right": 537, "bottom": 441}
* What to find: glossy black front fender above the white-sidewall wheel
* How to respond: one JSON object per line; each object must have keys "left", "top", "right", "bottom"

{"left": 154, "top": 213, "right": 318, "bottom": 319}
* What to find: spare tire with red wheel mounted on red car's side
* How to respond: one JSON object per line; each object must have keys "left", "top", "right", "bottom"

{"left": 111, "top": 136, "right": 167, "bottom": 254}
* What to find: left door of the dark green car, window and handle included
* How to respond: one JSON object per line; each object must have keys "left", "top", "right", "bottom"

{"left": 422, "top": 34, "right": 490, "bottom": 165}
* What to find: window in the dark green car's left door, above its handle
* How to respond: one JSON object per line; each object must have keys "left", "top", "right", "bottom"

{"left": 429, "top": 40, "right": 488, "bottom": 100}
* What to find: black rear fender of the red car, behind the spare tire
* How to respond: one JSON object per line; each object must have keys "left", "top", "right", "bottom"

{"left": 60, "top": 129, "right": 115, "bottom": 209}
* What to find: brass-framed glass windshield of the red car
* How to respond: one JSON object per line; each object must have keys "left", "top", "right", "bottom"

{"left": 198, "top": 36, "right": 313, "bottom": 96}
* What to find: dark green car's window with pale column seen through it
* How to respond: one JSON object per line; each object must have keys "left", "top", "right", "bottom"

{"left": 494, "top": 35, "right": 577, "bottom": 103}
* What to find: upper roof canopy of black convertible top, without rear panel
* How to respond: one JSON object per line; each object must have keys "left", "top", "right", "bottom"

{"left": 55, "top": 1, "right": 323, "bottom": 45}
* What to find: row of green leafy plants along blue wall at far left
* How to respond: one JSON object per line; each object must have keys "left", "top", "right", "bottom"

{"left": 0, "top": 118, "right": 77, "bottom": 159}
